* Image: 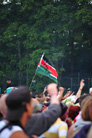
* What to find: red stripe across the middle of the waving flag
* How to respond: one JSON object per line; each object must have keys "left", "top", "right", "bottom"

{"left": 40, "top": 59, "right": 58, "bottom": 78}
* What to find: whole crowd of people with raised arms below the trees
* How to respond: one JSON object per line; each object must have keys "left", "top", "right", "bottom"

{"left": 0, "top": 79, "right": 92, "bottom": 138}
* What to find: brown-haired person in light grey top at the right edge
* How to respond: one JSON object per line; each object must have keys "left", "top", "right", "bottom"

{"left": 68, "top": 95, "right": 92, "bottom": 138}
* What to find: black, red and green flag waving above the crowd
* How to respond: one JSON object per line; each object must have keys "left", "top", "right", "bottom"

{"left": 36, "top": 54, "right": 58, "bottom": 83}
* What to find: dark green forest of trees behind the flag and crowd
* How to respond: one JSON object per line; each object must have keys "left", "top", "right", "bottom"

{"left": 0, "top": 0, "right": 92, "bottom": 93}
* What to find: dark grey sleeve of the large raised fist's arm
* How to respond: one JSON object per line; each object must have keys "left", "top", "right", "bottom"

{"left": 26, "top": 104, "right": 61, "bottom": 138}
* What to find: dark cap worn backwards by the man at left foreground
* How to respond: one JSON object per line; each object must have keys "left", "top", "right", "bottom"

{"left": 6, "top": 86, "right": 31, "bottom": 121}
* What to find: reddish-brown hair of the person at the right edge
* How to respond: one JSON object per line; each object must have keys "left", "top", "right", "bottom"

{"left": 81, "top": 96, "right": 92, "bottom": 121}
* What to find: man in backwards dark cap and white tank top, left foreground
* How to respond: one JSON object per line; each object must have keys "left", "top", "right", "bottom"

{"left": 0, "top": 86, "right": 33, "bottom": 138}
